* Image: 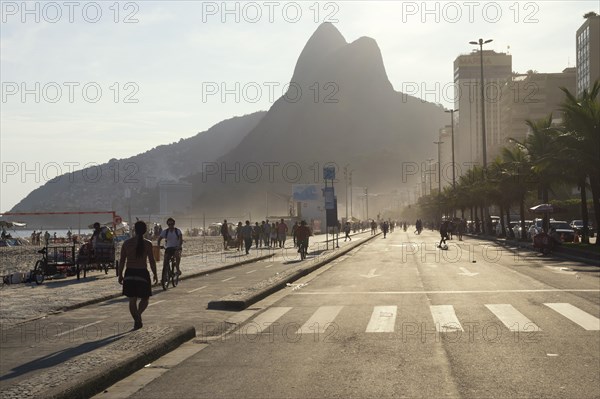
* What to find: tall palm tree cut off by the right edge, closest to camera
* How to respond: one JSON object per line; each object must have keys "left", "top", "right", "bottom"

{"left": 559, "top": 81, "right": 600, "bottom": 245}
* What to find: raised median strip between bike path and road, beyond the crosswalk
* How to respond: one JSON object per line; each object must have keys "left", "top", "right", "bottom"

{"left": 207, "top": 233, "right": 382, "bottom": 311}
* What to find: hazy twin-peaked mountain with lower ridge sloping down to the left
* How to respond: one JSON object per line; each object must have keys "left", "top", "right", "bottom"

{"left": 13, "top": 23, "right": 448, "bottom": 215}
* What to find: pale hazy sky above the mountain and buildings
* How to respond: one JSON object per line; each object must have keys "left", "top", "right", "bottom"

{"left": 0, "top": 0, "right": 600, "bottom": 211}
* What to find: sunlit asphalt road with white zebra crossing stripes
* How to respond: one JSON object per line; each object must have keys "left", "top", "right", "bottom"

{"left": 110, "top": 231, "right": 600, "bottom": 399}
